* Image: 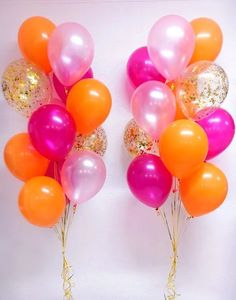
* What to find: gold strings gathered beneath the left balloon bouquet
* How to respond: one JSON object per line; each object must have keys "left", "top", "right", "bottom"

{"left": 54, "top": 162, "right": 76, "bottom": 300}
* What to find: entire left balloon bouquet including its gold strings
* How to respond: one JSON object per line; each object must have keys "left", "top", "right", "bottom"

{"left": 2, "top": 17, "right": 111, "bottom": 299}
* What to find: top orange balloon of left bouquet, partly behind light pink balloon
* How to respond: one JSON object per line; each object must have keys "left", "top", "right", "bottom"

{"left": 18, "top": 17, "right": 56, "bottom": 73}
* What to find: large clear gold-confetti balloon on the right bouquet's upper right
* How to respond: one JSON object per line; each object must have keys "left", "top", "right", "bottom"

{"left": 176, "top": 61, "right": 229, "bottom": 120}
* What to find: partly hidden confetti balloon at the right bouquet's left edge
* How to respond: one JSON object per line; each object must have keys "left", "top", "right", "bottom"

{"left": 124, "top": 119, "right": 158, "bottom": 157}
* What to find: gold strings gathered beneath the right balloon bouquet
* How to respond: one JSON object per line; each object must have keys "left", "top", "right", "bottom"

{"left": 157, "top": 179, "right": 186, "bottom": 300}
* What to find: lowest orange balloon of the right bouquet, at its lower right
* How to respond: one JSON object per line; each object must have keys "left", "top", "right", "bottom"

{"left": 180, "top": 163, "right": 228, "bottom": 217}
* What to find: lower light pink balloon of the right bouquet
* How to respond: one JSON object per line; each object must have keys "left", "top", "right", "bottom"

{"left": 131, "top": 81, "right": 176, "bottom": 139}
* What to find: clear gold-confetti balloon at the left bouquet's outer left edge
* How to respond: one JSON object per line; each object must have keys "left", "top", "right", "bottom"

{"left": 2, "top": 59, "right": 52, "bottom": 117}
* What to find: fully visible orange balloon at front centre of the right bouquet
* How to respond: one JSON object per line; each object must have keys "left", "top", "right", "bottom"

{"left": 159, "top": 120, "right": 208, "bottom": 178}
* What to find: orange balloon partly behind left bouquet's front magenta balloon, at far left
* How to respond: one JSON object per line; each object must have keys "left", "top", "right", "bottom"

{"left": 4, "top": 133, "right": 49, "bottom": 181}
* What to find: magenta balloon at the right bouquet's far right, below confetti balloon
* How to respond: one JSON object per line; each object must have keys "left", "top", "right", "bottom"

{"left": 197, "top": 108, "right": 235, "bottom": 160}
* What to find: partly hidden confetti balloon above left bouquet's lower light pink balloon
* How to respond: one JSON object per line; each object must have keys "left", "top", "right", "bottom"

{"left": 73, "top": 127, "right": 107, "bottom": 156}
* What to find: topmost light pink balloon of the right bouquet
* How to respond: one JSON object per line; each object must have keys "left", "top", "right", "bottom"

{"left": 147, "top": 15, "right": 195, "bottom": 80}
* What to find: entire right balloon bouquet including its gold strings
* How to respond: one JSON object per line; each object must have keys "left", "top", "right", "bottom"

{"left": 124, "top": 15, "right": 235, "bottom": 300}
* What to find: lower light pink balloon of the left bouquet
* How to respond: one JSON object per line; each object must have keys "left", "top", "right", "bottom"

{"left": 61, "top": 151, "right": 106, "bottom": 204}
